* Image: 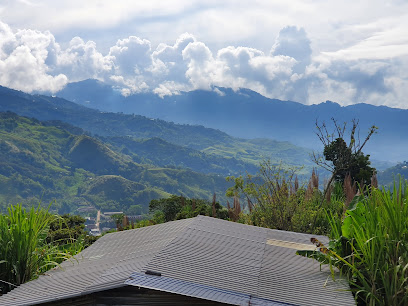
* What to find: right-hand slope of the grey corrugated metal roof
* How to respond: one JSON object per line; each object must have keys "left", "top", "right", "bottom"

{"left": 134, "top": 217, "right": 354, "bottom": 305}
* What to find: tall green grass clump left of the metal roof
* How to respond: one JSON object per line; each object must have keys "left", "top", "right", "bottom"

{"left": 0, "top": 204, "right": 91, "bottom": 293}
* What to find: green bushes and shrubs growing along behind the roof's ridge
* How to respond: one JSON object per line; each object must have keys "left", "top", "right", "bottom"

{"left": 125, "top": 161, "right": 346, "bottom": 234}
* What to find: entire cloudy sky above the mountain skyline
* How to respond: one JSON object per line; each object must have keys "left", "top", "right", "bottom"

{"left": 0, "top": 0, "right": 408, "bottom": 109}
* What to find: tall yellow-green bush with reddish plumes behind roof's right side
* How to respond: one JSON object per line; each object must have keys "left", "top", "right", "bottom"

{"left": 227, "top": 161, "right": 344, "bottom": 234}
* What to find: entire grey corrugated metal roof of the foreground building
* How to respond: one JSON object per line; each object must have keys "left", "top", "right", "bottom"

{"left": 0, "top": 216, "right": 354, "bottom": 306}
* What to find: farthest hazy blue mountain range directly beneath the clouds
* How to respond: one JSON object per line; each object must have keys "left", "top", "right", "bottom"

{"left": 56, "top": 80, "right": 408, "bottom": 163}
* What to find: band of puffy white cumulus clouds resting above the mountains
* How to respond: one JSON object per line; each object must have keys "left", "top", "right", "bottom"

{"left": 0, "top": 22, "right": 408, "bottom": 108}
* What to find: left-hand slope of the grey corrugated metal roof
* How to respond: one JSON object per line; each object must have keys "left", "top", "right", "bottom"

{"left": 0, "top": 219, "right": 194, "bottom": 306}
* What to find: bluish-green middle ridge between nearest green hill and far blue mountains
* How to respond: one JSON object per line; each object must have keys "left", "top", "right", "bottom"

{"left": 0, "top": 87, "right": 314, "bottom": 176}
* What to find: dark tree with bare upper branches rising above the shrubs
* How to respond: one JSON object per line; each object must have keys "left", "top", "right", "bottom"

{"left": 312, "top": 118, "right": 378, "bottom": 186}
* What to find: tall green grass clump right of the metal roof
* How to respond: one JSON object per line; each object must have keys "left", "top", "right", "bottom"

{"left": 315, "top": 180, "right": 408, "bottom": 305}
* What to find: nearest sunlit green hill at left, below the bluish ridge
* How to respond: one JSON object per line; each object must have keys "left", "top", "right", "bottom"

{"left": 0, "top": 112, "right": 233, "bottom": 213}
